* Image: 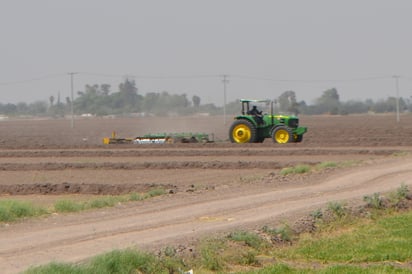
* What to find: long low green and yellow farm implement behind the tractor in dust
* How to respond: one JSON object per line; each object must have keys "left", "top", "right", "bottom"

{"left": 103, "top": 132, "right": 213, "bottom": 145}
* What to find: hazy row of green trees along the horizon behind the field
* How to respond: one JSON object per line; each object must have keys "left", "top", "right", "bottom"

{"left": 0, "top": 79, "right": 412, "bottom": 117}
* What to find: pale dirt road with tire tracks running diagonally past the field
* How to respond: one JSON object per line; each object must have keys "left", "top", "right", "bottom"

{"left": 0, "top": 157, "right": 412, "bottom": 273}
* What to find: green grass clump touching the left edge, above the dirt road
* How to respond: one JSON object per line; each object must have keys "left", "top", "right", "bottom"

{"left": 0, "top": 200, "right": 47, "bottom": 222}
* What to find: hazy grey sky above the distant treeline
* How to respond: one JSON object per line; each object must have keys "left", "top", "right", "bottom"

{"left": 0, "top": 0, "right": 412, "bottom": 105}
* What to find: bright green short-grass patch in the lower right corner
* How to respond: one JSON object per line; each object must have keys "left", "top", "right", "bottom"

{"left": 278, "top": 212, "right": 412, "bottom": 263}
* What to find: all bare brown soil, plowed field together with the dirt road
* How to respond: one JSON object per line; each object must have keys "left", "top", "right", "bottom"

{"left": 0, "top": 115, "right": 412, "bottom": 273}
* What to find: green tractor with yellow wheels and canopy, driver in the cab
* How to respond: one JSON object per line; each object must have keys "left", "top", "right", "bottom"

{"left": 229, "top": 99, "right": 307, "bottom": 144}
